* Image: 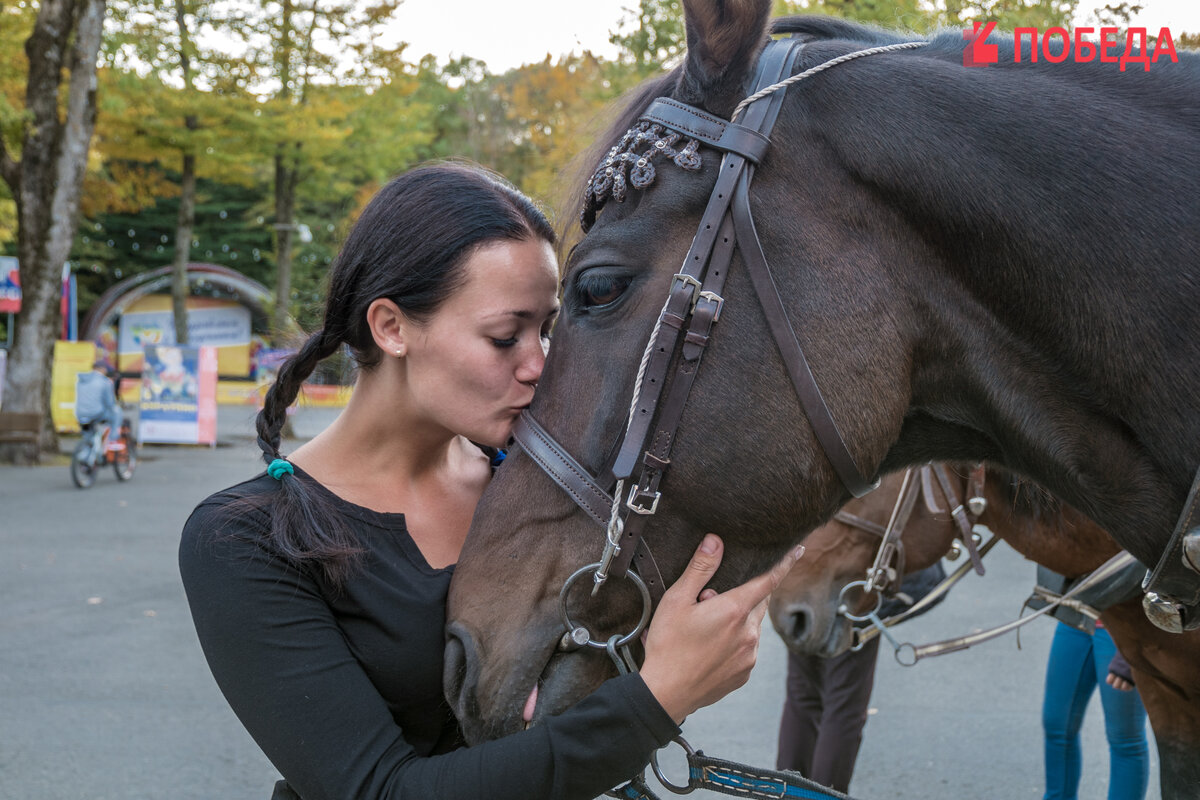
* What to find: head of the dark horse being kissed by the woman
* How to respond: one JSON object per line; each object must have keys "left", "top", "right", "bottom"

{"left": 445, "top": 0, "right": 921, "bottom": 740}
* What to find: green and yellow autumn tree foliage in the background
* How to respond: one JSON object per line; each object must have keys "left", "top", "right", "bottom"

{"left": 0, "top": 0, "right": 1152, "bottom": 343}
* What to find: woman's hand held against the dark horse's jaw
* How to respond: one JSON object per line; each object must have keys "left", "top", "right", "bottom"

{"left": 640, "top": 534, "right": 804, "bottom": 723}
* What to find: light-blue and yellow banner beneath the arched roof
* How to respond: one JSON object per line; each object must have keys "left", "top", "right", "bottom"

{"left": 116, "top": 295, "right": 251, "bottom": 378}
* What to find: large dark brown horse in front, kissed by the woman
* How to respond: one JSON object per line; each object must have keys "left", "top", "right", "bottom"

{"left": 444, "top": 0, "right": 1200, "bottom": 741}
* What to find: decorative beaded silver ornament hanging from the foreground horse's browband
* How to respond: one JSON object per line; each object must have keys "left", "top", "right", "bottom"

{"left": 580, "top": 120, "right": 701, "bottom": 233}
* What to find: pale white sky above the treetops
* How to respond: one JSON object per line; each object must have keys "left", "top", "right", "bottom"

{"left": 394, "top": 0, "right": 1200, "bottom": 72}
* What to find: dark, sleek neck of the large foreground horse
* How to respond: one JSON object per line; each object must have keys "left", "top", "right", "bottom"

{"left": 800, "top": 56, "right": 1200, "bottom": 564}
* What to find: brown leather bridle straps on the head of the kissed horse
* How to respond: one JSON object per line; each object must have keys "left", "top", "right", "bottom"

{"left": 514, "top": 38, "right": 877, "bottom": 618}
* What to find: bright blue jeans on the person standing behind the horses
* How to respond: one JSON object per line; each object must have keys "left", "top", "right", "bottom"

{"left": 1042, "top": 622, "right": 1150, "bottom": 800}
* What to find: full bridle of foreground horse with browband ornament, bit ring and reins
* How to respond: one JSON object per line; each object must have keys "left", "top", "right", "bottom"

{"left": 514, "top": 37, "right": 924, "bottom": 800}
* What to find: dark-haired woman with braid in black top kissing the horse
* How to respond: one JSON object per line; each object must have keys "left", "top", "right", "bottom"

{"left": 180, "top": 164, "right": 794, "bottom": 800}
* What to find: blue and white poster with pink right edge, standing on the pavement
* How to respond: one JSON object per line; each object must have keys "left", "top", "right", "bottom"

{"left": 138, "top": 344, "right": 217, "bottom": 445}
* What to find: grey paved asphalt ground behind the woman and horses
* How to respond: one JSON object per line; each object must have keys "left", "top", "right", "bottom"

{"left": 0, "top": 408, "right": 1158, "bottom": 800}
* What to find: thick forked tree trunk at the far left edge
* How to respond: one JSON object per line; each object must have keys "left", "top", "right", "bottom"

{"left": 0, "top": 0, "right": 106, "bottom": 458}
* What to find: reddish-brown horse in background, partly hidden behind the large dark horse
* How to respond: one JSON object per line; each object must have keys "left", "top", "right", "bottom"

{"left": 769, "top": 469, "right": 1200, "bottom": 800}
